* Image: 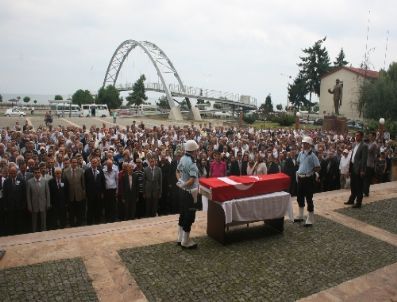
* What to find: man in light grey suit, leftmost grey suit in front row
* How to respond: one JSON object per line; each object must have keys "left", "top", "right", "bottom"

{"left": 26, "top": 166, "right": 51, "bottom": 232}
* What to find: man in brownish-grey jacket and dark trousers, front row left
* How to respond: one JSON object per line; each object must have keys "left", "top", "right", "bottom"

{"left": 63, "top": 157, "right": 85, "bottom": 226}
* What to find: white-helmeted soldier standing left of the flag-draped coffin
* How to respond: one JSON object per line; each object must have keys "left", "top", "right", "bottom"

{"left": 176, "top": 140, "right": 199, "bottom": 249}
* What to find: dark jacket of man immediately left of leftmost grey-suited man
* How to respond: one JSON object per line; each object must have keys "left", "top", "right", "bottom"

{"left": 3, "top": 176, "right": 27, "bottom": 211}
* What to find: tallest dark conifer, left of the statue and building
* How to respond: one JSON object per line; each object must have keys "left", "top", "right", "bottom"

{"left": 298, "top": 37, "right": 330, "bottom": 102}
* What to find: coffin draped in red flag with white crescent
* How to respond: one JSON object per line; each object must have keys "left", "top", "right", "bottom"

{"left": 200, "top": 173, "right": 290, "bottom": 202}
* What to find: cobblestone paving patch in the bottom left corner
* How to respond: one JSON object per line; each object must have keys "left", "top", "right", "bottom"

{"left": 0, "top": 258, "right": 98, "bottom": 302}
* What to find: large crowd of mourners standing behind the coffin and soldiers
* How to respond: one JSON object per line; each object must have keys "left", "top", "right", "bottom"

{"left": 0, "top": 121, "right": 397, "bottom": 235}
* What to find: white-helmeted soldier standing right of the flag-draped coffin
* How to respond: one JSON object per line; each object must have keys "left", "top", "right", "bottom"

{"left": 294, "top": 136, "right": 320, "bottom": 227}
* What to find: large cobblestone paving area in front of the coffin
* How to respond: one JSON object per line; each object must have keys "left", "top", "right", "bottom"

{"left": 119, "top": 216, "right": 397, "bottom": 301}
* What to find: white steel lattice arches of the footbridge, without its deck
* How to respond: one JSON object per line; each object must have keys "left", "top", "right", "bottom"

{"left": 102, "top": 40, "right": 185, "bottom": 109}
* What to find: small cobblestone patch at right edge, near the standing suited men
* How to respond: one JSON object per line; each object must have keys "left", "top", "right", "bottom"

{"left": 337, "top": 198, "right": 397, "bottom": 234}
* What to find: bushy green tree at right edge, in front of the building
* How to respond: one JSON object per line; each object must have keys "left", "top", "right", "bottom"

{"left": 358, "top": 62, "right": 397, "bottom": 120}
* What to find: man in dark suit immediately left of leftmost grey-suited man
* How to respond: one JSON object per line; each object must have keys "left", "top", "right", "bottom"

{"left": 3, "top": 166, "right": 29, "bottom": 235}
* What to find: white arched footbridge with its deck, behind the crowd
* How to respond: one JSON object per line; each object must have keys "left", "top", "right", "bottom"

{"left": 102, "top": 40, "right": 257, "bottom": 120}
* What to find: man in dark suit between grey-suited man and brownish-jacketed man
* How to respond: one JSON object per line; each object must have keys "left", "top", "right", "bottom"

{"left": 48, "top": 167, "right": 69, "bottom": 229}
